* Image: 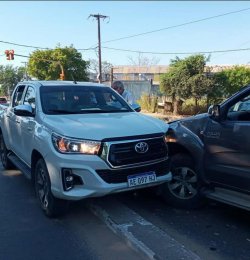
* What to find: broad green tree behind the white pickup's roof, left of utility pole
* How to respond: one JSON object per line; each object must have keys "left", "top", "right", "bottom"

{"left": 28, "top": 46, "right": 89, "bottom": 81}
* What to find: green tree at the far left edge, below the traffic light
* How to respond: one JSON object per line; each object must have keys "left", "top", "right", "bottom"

{"left": 0, "top": 65, "right": 25, "bottom": 96}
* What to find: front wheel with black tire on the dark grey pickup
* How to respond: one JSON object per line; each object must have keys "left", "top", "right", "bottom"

{"left": 161, "top": 154, "right": 204, "bottom": 209}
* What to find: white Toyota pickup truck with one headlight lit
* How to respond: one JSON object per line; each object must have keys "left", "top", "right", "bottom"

{"left": 0, "top": 81, "right": 171, "bottom": 217}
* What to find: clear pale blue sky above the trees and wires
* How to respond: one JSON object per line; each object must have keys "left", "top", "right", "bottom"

{"left": 0, "top": 1, "right": 250, "bottom": 66}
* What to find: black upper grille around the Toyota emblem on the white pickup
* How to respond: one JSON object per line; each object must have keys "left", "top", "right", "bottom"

{"left": 108, "top": 137, "right": 168, "bottom": 167}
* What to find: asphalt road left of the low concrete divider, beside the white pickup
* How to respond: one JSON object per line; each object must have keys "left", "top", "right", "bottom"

{"left": 0, "top": 166, "right": 144, "bottom": 260}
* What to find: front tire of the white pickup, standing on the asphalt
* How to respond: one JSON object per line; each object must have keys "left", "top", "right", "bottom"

{"left": 34, "top": 159, "right": 69, "bottom": 218}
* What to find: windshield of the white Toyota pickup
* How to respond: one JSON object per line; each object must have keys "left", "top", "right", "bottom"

{"left": 40, "top": 84, "right": 133, "bottom": 115}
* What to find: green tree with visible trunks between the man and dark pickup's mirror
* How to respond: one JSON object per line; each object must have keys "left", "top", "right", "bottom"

{"left": 160, "top": 54, "right": 213, "bottom": 114}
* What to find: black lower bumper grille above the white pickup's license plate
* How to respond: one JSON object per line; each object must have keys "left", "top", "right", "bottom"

{"left": 96, "top": 160, "right": 169, "bottom": 184}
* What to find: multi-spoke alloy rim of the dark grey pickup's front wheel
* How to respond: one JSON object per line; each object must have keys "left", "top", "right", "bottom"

{"left": 168, "top": 167, "right": 198, "bottom": 199}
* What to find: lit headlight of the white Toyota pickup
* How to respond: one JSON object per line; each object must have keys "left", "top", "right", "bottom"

{"left": 52, "top": 133, "right": 101, "bottom": 154}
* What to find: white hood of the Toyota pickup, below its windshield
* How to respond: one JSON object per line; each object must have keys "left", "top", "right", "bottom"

{"left": 43, "top": 112, "right": 168, "bottom": 140}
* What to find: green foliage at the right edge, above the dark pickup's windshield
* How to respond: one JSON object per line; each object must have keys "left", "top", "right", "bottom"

{"left": 215, "top": 66, "right": 250, "bottom": 98}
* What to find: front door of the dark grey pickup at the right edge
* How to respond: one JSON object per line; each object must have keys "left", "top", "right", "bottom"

{"left": 204, "top": 93, "right": 250, "bottom": 192}
